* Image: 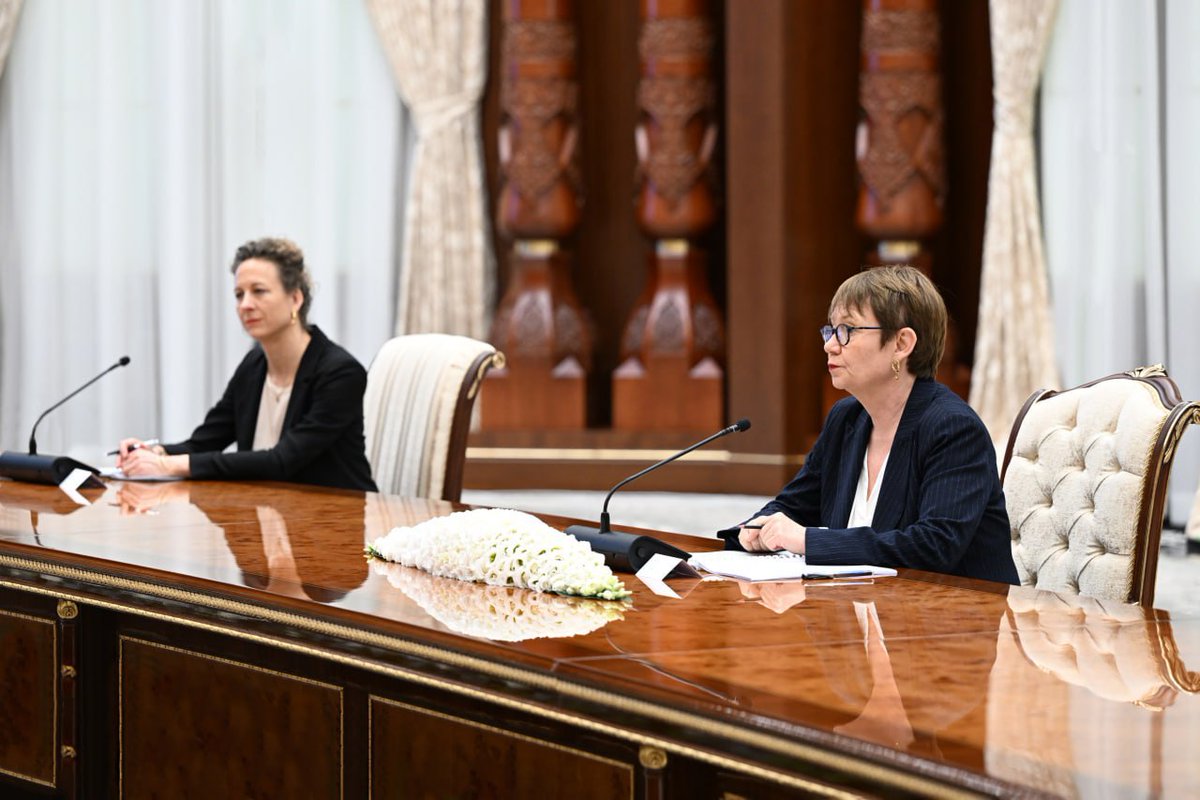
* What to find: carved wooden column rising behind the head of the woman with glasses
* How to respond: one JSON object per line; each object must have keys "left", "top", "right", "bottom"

{"left": 849, "top": 0, "right": 971, "bottom": 398}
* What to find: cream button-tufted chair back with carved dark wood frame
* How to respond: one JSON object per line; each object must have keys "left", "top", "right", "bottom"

{"left": 1001, "top": 365, "right": 1200, "bottom": 606}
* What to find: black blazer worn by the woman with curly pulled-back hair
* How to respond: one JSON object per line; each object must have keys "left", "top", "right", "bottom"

{"left": 166, "top": 326, "right": 376, "bottom": 492}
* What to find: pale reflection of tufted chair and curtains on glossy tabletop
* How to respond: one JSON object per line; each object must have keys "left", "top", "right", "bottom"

{"left": 986, "top": 587, "right": 1200, "bottom": 796}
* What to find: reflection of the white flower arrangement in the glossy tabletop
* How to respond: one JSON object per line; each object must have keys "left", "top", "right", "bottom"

{"left": 371, "top": 560, "right": 624, "bottom": 642}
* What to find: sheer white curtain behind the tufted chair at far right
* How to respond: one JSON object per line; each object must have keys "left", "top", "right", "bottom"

{"left": 1040, "top": 0, "right": 1200, "bottom": 524}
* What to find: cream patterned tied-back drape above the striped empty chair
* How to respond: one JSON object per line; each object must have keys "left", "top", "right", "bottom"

{"left": 367, "top": 0, "right": 494, "bottom": 338}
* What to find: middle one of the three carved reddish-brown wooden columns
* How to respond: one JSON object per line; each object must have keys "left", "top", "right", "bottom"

{"left": 613, "top": 0, "right": 725, "bottom": 429}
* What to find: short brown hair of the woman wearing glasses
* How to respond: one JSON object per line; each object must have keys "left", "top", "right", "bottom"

{"left": 829, "top": 266, "right": 946, "bottom": 378}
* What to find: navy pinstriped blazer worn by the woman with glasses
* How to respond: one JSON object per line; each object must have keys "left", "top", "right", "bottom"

{"left": 755, "top": 378, "right": 1018, "bottom": 584}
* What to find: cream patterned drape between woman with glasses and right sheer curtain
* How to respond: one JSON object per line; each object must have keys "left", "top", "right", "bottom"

{"left": 971, "top": 0, "right": 1058, "bottom": 443}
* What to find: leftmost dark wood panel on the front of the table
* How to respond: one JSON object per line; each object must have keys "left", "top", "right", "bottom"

{"left": 0, "top": 609, "right": 59, "bottom": 786}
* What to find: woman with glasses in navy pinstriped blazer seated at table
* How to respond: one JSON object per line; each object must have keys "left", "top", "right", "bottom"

{"left": 737, "top": 266, "right": 1018, "bottom": 583}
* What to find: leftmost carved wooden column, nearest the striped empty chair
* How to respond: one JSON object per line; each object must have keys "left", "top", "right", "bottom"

{"left": 480, "top": 0, "right": 593, "bottom": 429}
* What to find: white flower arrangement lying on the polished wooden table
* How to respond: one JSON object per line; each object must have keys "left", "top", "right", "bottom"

{"left": 366, "top": 509, "right": 631, "bottom": 600}
